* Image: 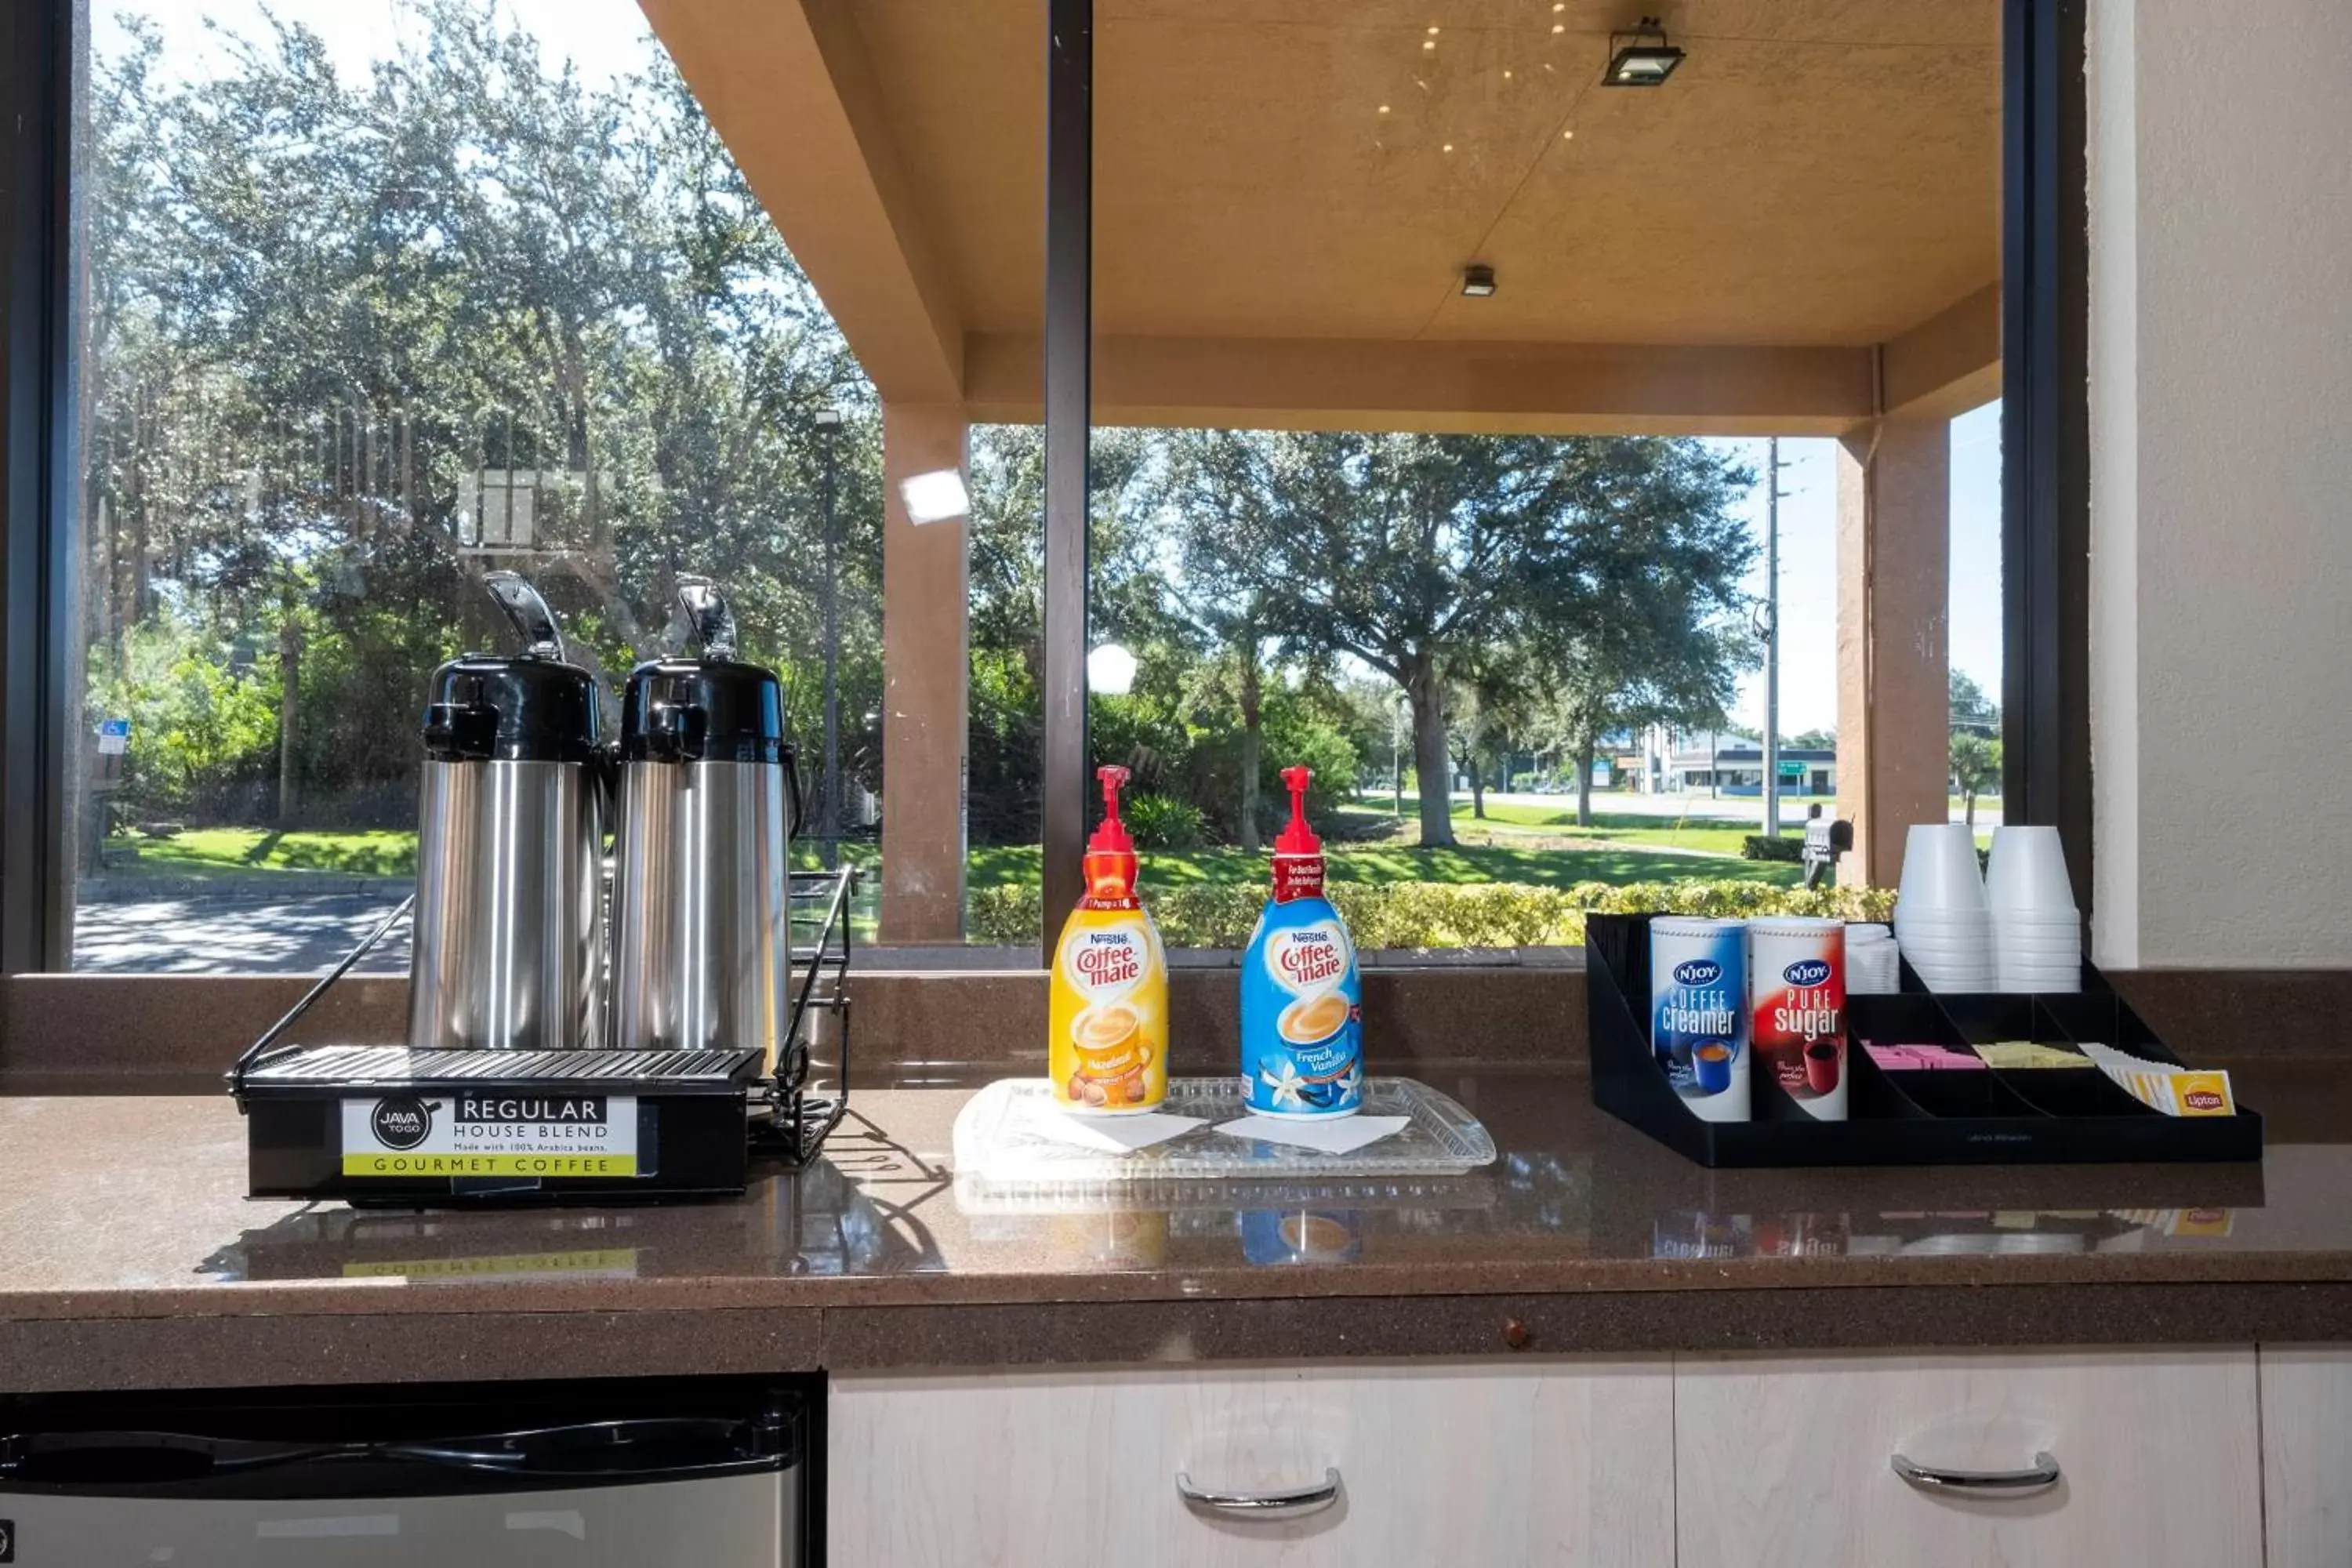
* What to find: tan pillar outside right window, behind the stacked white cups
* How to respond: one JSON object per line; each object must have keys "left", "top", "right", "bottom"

{"left": 1837, "top": 419, "right": 1952, "bottom": 886}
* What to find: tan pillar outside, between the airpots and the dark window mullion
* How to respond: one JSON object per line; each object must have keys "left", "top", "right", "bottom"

{"left": 880, "top": 405, "right": 971, "bottom": 942}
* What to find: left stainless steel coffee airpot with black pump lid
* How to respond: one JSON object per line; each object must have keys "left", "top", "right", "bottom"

{"left": 409, "top": 572, "right": 604, "bottom": 1051}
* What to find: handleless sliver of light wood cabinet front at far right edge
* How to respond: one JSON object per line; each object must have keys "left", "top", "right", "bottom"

{"left": 2263, "top": 1345, "right": 2352, "bottom": 1568}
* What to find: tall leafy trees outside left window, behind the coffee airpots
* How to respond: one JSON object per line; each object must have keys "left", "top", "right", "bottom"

{"left": 82, "top": 0, "right": 882, "bottom": 822}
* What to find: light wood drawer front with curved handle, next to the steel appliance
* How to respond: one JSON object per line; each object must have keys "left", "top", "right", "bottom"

{"left": 828, "top": 1356, "right": 1675, "bottom": 1568}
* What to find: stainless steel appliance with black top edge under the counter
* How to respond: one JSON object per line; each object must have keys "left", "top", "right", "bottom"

{"left": 0, "top": 1380, "right": 816, "bottom": 1568}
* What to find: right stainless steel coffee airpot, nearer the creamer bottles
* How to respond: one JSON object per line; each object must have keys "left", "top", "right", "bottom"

{"left": 612, "top": 579, "right": 800, "bottom": 1069}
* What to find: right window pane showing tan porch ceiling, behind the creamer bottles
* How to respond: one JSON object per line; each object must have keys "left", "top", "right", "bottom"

{"left": 1068, "top": 0, "right": 2002, "bottom": 947}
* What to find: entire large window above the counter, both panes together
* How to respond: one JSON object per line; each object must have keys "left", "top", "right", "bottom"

{"left": 12, "top": 0, "right": 2079, "bottom": 971}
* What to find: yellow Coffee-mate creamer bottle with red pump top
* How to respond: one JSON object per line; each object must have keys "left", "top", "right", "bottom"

{"left": 1047, "top": 769, "right": 1169, "bottom": 1116}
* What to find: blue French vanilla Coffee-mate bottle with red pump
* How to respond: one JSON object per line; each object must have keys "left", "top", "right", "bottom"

{"left": 1242, "top": 769, "right": 1364, "bottom": 1119}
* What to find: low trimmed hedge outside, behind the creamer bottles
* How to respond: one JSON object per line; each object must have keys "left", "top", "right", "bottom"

{"left": 967, "top": 881, "right": 1896, "bottom": 949}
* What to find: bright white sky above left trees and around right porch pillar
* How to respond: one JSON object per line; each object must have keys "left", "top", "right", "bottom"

{"left": 92, "top": 0, "right": 2002, "bottom": 734}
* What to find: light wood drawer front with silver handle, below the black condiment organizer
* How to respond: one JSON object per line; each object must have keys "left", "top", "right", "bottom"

{"left": 1675, "top": 1347, "right": 2258, "bottom": 1568}
